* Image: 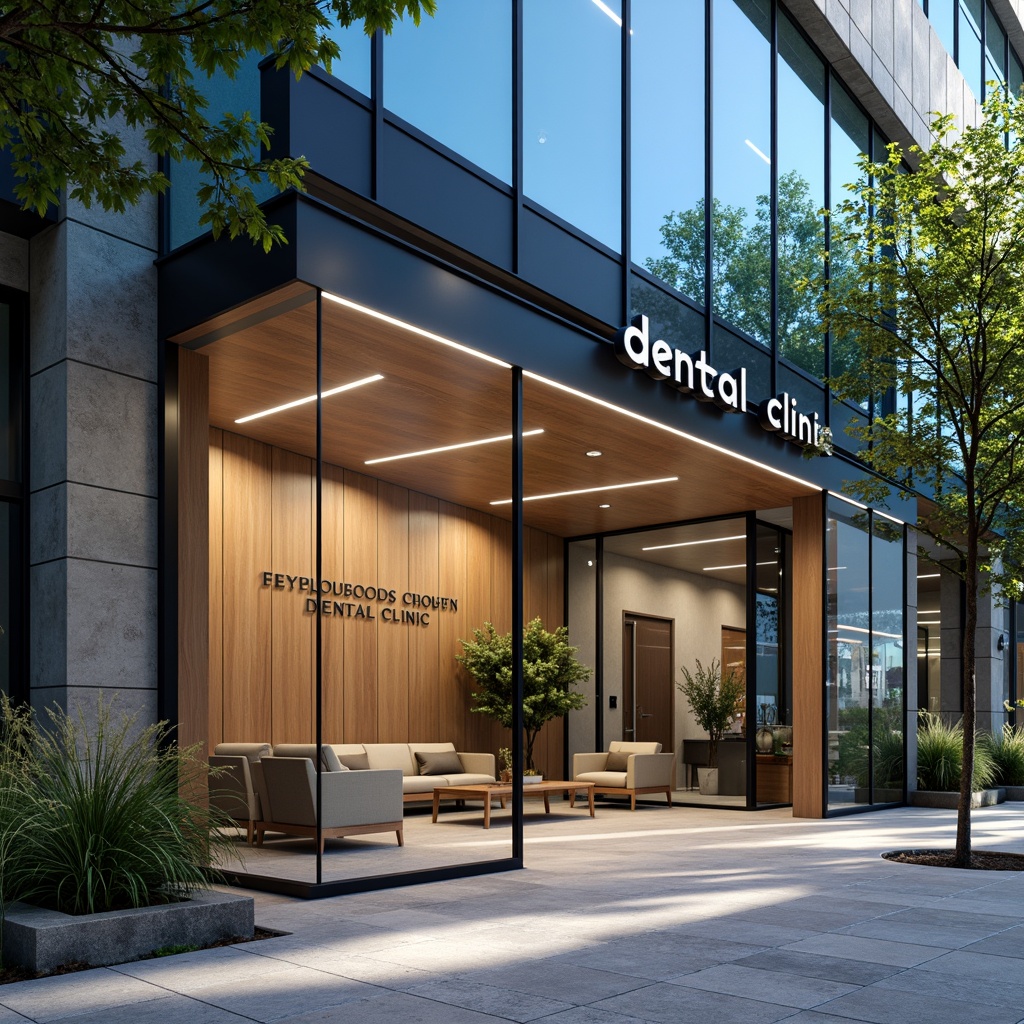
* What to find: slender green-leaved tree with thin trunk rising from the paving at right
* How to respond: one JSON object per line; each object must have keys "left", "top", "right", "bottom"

{"left": 821, "top": 88, "right": 1024, "bottom": 867}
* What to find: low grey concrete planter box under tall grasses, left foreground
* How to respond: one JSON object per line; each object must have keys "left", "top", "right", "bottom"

{"left": 3, "top": 891, "right": 254, "bottom": 972}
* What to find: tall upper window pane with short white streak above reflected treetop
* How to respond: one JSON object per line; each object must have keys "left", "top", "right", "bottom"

{"left": 712, "top": 0, "right": 771, "bottom": 345}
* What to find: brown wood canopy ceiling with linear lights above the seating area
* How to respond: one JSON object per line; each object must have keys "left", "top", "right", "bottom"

{"left": 190, "top": 294, "right": 808, "bottom": 537}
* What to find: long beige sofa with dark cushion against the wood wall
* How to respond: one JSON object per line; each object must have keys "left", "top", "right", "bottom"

{"left": 329, "top": 743, "right": 497, "bottom": 803}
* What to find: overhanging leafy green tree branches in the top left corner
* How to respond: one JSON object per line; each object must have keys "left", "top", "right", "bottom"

{"left": 0, "top": 0, "right": 435, "bottom": 249}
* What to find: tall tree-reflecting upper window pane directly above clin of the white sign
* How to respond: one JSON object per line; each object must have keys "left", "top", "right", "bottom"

{"left": 776, "top": 15, "right": 825, "bottom": 377}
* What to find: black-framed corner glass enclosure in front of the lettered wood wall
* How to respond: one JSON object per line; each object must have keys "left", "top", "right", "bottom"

{"left": 203, "top": 291, "right": 520, "bottom": 895}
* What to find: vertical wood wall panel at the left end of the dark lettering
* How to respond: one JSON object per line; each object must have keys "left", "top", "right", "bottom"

{"left": 222, "top": 432, "right": 271, "bottom": 742}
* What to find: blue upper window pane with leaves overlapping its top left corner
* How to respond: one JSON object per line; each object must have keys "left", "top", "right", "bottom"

{"left": 384, "top": 0, "right": 512, "bottom": 181}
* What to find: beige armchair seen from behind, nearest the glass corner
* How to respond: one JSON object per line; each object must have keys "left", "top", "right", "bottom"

{"left": 253, "top": 746, "right": 406, "bottom": 853}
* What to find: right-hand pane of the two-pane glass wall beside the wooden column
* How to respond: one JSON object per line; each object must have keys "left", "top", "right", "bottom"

{"left": 870, "top": 515, "right": 906, "bottom": 804}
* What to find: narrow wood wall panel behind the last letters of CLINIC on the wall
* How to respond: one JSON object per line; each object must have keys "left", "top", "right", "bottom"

{"left": 409, "top": 490, "right": 440, "bottom": 742}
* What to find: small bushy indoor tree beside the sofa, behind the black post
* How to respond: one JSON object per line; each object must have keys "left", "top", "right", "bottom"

{"left": 456, "top": 618, "right": 591, "bottom": 769}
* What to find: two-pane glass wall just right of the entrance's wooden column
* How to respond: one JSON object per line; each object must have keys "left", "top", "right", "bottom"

{"left": 825, "top": 498, "right": 906, "bottom": 811}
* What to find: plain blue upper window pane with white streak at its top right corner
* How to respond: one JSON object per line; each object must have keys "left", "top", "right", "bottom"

{"left": 523, "top": 0, "right": 622, "bottom": 249}
